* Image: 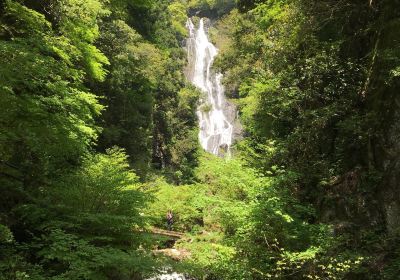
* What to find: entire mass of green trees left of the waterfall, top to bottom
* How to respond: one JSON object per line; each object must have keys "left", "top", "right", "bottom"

{"left": 0, "top": 0, "right": 198, "bottom": 279}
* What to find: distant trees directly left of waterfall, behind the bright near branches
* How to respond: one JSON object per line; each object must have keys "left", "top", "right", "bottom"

{"left": 91, "top": 1, "right": 197, "bottom": 179}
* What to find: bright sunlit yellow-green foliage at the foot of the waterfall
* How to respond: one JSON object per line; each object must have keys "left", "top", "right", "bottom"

{"left": 147, "top": 155, "right": 365, "bottom": 279}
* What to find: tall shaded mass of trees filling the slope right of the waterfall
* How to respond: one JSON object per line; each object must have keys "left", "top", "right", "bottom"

{"left": 211, "top": 0, "right": 400, "bottom": 279}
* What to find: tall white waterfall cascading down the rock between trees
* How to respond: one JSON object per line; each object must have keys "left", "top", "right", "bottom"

{"left": 187, "top": 19, "right": 234, "bottom": 156}
